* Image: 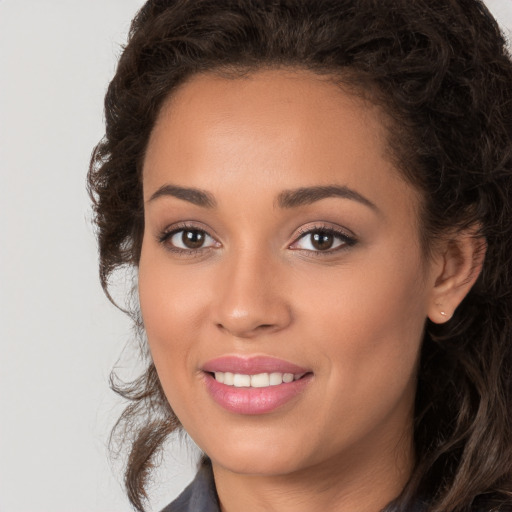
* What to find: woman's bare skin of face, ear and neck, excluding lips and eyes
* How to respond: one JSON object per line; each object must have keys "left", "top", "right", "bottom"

{"left": 139, "top": 70, "right": 482, "bottom": 512}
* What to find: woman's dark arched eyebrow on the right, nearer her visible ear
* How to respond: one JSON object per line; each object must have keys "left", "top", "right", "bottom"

{"left": 277, "top": 185, "right": 379, "bottom": 212}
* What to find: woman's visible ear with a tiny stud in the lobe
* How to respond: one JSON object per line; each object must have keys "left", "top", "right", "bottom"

{"left": 428, "top": 229, "right": 487, "bottom": 324}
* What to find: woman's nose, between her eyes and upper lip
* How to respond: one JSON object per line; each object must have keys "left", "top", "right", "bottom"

{"left": 213, "top": 249, "right": 292, "bottom": 338}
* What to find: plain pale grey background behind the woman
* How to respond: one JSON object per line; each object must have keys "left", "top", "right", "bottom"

{"left": 0, "top": 0, "right": 512, "bottom": 512}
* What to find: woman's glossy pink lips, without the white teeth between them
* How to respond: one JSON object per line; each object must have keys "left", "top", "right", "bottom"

{"left": 202, "top": 356, "right": 313, "bottom": 414}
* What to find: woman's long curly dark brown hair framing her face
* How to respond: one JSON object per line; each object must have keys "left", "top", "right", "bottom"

{"left": 88, "top": 0, "right": 512, "bottom": 512}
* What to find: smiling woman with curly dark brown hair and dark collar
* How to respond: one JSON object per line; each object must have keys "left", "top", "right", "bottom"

{"left": 89, "top": 0, "right": 512, "bottom": 512}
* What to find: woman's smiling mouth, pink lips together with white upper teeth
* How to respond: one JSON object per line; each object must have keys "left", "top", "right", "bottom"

{"left": 202, "top": 356, "right": 313, "bottom": 414}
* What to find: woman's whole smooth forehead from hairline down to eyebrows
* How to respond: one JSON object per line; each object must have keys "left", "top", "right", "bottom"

{"left": 144, "top": 69, "right": 420, "bottom": 220}
